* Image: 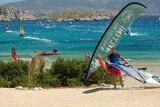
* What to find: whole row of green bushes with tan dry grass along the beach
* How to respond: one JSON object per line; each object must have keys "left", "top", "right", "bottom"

{"left": 0, "top": 58, "right": 111, "bottom": 88}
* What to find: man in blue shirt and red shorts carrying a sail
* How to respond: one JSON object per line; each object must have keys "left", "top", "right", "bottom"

{"left": 107, "top": 48, "right": 128, "bottom": 88}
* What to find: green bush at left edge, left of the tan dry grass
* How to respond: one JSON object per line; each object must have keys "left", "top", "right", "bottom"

{"left": 0, "top": 61, "right": 28, "bottom": 87}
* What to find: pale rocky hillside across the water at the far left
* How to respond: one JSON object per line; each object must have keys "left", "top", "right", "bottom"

{"left": 0, "top": 6, "right": 36, "bottom": 20}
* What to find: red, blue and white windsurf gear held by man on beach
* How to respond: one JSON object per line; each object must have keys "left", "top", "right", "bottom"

{"left": 97, "top": 56, "right": 160, "bottom": 85}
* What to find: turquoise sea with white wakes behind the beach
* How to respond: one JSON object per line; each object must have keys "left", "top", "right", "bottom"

{"left": 0, "top": 16, "right": 160, "bottom": 60}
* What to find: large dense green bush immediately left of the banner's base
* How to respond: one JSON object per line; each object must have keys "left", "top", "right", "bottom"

{"left": 50, "top": 58, "right": 88, "bottom": 86}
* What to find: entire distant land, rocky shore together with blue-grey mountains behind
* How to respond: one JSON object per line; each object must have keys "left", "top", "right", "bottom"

{"left": 0, "top": 0, "right": 160, "bottom": 21}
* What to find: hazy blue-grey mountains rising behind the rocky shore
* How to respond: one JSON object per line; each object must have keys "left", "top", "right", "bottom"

{"left": 7, "top": 0, "right": 160, "bottom": 14}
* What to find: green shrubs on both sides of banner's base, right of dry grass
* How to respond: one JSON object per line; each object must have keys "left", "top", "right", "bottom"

{"left": 50, "top": 58, "right": 111, "bottom": 87}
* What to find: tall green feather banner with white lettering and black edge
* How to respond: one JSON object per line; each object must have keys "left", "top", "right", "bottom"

{"left": 87, "top": 2, "right": 147, "bottom": 78}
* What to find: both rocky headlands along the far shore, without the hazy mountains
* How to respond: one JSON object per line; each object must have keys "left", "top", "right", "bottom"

{"left": 0, "top": 6, "right": 117, "bottom": 21}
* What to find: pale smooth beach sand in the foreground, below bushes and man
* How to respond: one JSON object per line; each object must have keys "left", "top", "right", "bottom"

{"left": 0, "top": 63, "right": 160, "bottom": 107}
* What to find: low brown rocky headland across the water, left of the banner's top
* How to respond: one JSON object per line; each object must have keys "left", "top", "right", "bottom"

{"left": 49, "top": 9, "right": 117, "bottom": 21}
